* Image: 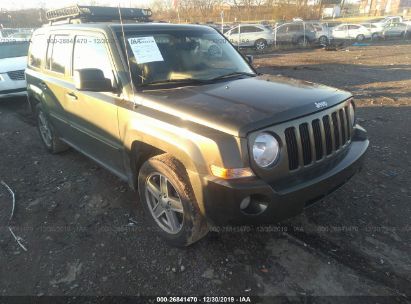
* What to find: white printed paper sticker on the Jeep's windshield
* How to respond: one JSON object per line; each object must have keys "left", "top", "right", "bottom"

{"left": 128, "top": 36, "right": 164, "bottom": 64}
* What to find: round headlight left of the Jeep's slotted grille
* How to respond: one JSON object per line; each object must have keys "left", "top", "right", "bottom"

{"left": 253, "top": 132, "right": 280, "bottom": 168}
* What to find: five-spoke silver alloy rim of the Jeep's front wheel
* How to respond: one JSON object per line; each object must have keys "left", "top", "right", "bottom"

{"left": 145, "top": 172, "right": 184, "bottom": 234}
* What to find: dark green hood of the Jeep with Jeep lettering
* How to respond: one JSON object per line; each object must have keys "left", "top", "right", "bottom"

{"left": 138, "top": 75, "right": 351, "bottom": 137}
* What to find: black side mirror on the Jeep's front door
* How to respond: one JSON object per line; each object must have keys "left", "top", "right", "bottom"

{"left": 74, "top": 69, "right": 113, "bottom": 92}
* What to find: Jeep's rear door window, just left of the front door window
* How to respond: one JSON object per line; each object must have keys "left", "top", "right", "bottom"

{"left": 46, "top": 35, "right": 72, "bottom": 74}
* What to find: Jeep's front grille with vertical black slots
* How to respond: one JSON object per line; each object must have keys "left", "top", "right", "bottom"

{"left": 284, "top": 106, "right": 351, "bottom": 170}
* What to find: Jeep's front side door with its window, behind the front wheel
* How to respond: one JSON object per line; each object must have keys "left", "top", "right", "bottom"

{"left": 65, "top": 32, "right": 124, "bottom": 176}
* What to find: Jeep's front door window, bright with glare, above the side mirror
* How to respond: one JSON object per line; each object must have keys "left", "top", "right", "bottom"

{"left": 73, "top": 36, "right": 115, "bottom": 85}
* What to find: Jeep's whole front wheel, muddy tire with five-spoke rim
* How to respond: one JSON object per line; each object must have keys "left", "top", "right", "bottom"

{"left": 138, "top": 154, "right": 208, "bottom": 247}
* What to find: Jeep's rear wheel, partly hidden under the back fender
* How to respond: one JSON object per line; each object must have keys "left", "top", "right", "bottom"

{"left": 36, "top": 103, "right": 69, "bottom": 154}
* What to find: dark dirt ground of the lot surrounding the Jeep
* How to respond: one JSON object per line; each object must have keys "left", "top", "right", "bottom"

{"left": 0, "top": 44, "right": 411, "bottom": 303}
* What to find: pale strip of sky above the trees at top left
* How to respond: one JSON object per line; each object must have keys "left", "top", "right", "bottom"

{"left": 0, "top": 0, "right": 148, "bottom": 10}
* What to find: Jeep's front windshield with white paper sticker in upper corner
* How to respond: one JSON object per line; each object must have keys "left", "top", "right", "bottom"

{"left": 117, "top": 29, "right": 255, "bottom": 86}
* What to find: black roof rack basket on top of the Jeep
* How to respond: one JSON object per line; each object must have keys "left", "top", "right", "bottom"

{"left": 46, "top": 5, "right": 152, "bottom": 24}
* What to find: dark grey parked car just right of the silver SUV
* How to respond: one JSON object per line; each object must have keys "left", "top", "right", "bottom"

{"left": 274, "top": 22, "right": 316, "bottom": 45}
